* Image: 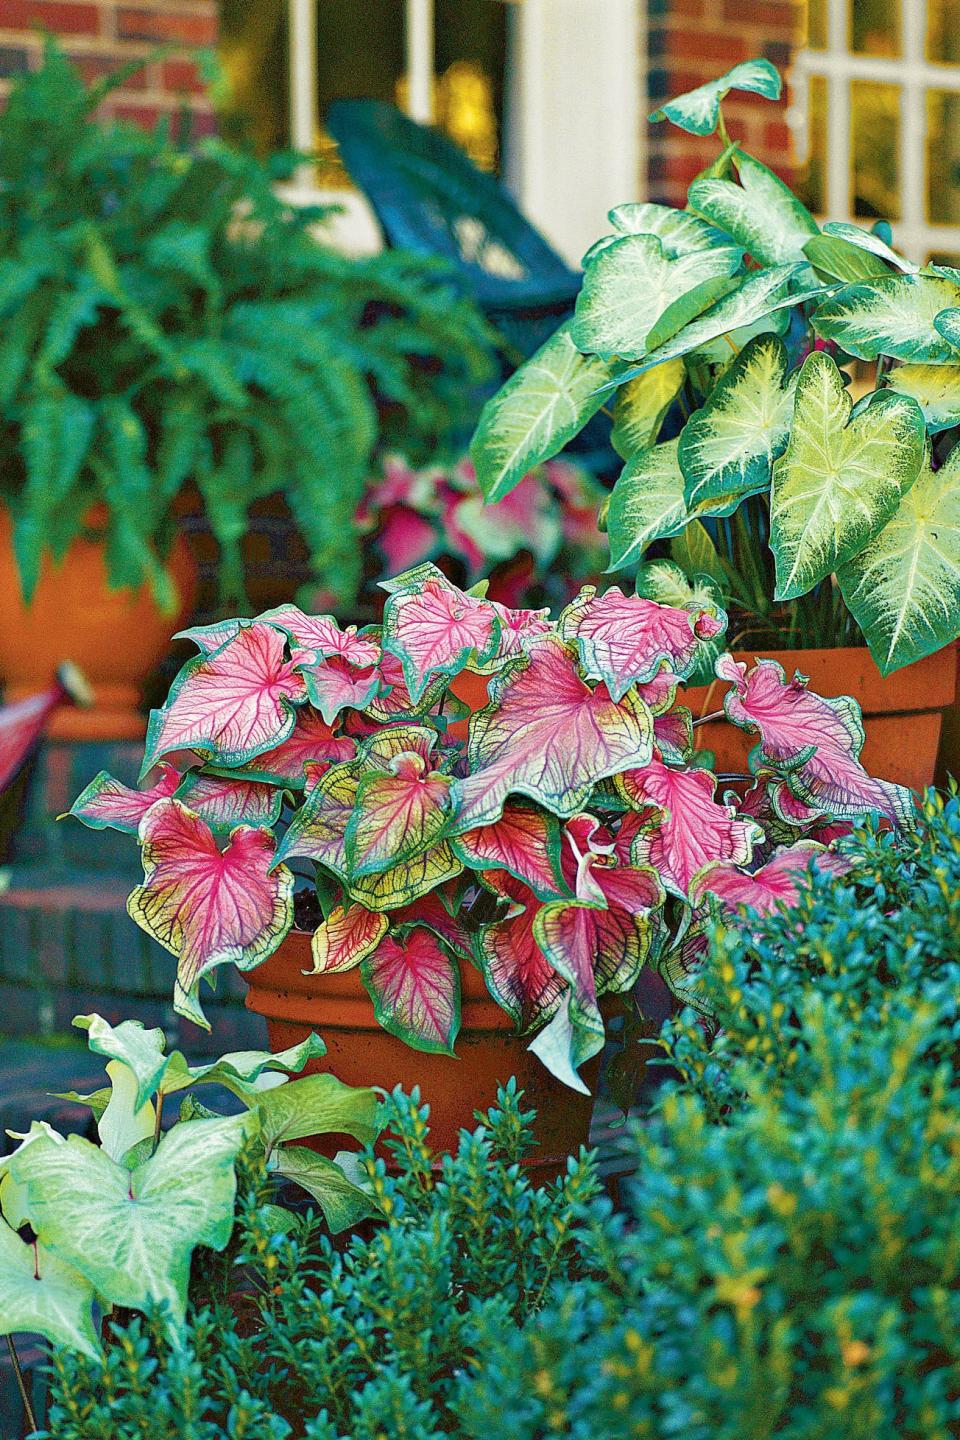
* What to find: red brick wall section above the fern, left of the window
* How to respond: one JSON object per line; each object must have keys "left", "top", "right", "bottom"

{"left": 0, "top": 0, "right": 217, "bottom": 134}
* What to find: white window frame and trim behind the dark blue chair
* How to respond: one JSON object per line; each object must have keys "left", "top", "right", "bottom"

{"left": 286, "top": 0, "right": 646, "bottom": 265}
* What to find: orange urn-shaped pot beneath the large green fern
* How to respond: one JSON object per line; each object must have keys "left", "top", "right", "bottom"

{"left": 0, "top": 505, "right": 197, "bottom": 740}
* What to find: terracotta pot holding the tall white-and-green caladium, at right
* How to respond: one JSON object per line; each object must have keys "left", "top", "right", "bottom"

{"left": 682, "top": 645, "right": 957, "bottom": 789}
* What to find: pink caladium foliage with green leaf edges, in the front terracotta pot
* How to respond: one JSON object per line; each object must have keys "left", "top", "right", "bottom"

{"left": 73, "top": 564, "right": 913, "bottom": 1086}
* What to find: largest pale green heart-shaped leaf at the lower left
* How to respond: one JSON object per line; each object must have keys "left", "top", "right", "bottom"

{"left": 12, "top": 1115, "right": 255, "bottom": 1329}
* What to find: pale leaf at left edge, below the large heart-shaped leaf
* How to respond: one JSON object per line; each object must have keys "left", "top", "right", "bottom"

{"left": 0, "top": 1220, "right": 99, "bottom": 1359}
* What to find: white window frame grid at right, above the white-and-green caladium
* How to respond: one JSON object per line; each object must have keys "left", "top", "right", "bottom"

{"left": 793, "top": 0, "right": 960, "bottom": 264}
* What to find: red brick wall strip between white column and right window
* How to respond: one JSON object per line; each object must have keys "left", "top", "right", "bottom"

{"left": 648, "top": 0, "right": 805, "bottom": 204}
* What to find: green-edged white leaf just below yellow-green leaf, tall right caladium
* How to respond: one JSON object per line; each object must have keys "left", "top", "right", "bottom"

{"left": 607, "top": 439, "right": 689, "bottom": 570}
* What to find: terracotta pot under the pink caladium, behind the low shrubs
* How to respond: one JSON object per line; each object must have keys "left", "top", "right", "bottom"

{"left": 243, "top": 930, "right": 600, "bottom": 1181}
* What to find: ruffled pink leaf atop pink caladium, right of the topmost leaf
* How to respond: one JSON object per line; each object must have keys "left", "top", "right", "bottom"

{"left": 560, "top": 585, "right": 727, "bottom": 700}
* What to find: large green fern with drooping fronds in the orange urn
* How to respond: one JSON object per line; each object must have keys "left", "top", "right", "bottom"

{"left": 0, "top": 42, "right": 492, "bottom": 603}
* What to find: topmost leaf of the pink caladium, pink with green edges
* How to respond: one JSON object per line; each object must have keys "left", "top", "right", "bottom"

{"left": 383, "top": 564, "right": 499, "bottom": 701}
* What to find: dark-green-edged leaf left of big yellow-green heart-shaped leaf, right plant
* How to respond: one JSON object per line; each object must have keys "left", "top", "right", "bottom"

{"left": 678, "top": 336, "right": 796, "bottom": 516}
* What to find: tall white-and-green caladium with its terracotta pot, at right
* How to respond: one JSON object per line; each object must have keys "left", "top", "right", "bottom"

{"left": 472, "top": 60, "right": 960, "bottom": 785}
